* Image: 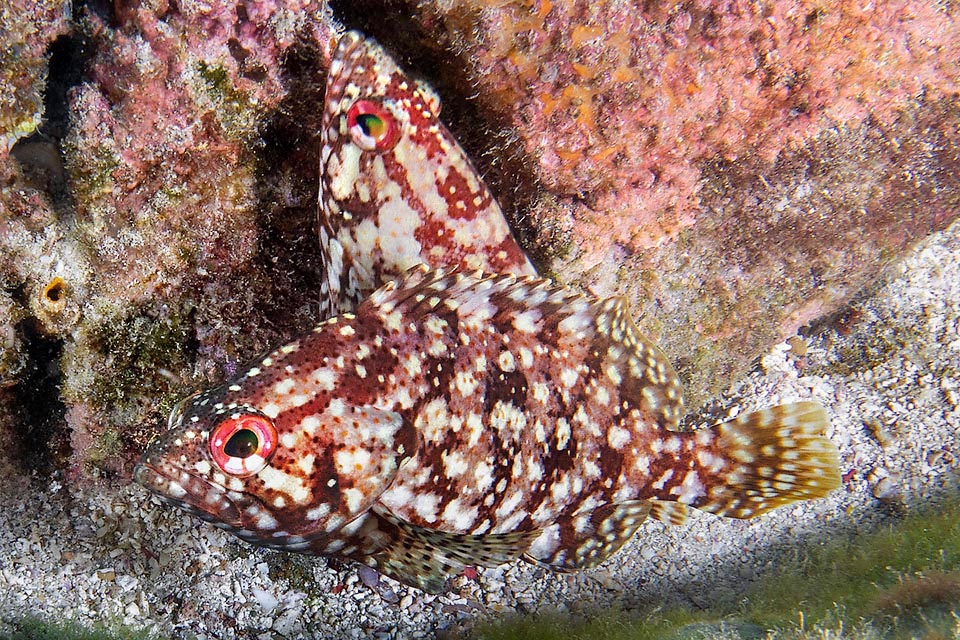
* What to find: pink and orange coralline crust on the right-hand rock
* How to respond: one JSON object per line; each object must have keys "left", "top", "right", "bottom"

{"left": 437, "top": 0, "right": 960, "bottom": 235}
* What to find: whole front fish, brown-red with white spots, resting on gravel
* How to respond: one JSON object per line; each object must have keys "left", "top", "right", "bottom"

{"left": 135, "top": 265, "right": 840, "bottom": 593}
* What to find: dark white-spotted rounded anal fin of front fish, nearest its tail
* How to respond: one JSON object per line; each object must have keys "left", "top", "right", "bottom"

{"left": 523, "top": 500, "right": 653, "bottom": 571}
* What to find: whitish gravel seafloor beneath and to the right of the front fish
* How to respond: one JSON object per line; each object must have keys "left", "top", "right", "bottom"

{"left": 0, "top": 218, "right": 960, "bottom": 640}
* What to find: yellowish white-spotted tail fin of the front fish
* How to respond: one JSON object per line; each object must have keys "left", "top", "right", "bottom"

{"left": 694, "top": 402, "right": 840, "bottom": 518}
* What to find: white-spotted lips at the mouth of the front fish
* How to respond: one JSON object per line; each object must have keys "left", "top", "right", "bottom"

{"left": 133, "top": 459, "right": 243, "bottom": 529}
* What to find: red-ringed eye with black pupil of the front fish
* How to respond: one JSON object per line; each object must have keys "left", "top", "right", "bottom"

{"left": 210, "top": 413, "right": 277, "bottom": 478}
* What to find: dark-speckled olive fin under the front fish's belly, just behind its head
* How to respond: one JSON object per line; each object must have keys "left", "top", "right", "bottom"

{"left": 373, "top": 506, "right": 540, "bottom": 593}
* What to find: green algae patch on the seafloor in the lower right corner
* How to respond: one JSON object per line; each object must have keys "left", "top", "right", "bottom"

{"left": 470, "top": 497, "right": 960, "bottom": 640}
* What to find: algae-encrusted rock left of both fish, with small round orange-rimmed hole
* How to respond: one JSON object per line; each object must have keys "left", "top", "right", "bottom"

{"left": 0, "top": 0, "right": 332, "bottom": 477}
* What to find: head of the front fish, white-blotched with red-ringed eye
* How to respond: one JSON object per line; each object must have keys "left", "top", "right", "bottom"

{"left": 134, "top": 348, "right": 416, "bottom": 550}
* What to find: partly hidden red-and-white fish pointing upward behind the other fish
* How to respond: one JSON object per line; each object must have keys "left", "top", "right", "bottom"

{"left": 318, "top": 31, "right": 537, "bottom": 317}
